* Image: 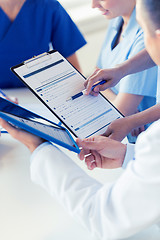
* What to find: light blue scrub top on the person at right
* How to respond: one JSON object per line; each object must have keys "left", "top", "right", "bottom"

{"left": 97, "top": 9, "right": 157, "bottom": 124}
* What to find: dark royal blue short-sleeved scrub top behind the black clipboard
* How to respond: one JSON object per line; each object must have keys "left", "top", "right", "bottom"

{"left": 0, "top": 0, "right": 86, "bottom": 88}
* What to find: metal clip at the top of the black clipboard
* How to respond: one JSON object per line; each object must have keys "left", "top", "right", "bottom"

{"left": 23, "top": 52, "right": 51, "bottom": 68}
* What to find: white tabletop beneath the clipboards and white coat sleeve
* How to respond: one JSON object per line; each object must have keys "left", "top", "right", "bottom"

{"left": 0, "top": 89, "right": 160, "bottom": 240}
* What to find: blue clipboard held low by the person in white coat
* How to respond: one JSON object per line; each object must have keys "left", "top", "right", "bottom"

{"left": 0, "top": 97, "right": 80, "bottom": 153}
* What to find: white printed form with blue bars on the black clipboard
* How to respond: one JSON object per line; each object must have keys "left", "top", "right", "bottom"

{"left": 14, "top": 51, "right": 122, "bottom": 138}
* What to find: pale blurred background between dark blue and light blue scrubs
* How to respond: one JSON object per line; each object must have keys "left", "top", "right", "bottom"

{"left": 59, "top": 0, "right": 108, "bottom": 76}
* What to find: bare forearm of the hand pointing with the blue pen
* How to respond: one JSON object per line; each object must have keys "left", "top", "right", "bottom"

{"left": 117, "top": 49, "right": 155, "bottom": 77}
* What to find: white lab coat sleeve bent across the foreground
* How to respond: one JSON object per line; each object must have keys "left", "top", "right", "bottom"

{"left": 31, "top": 122, "right": 160, "bottom": 240}
